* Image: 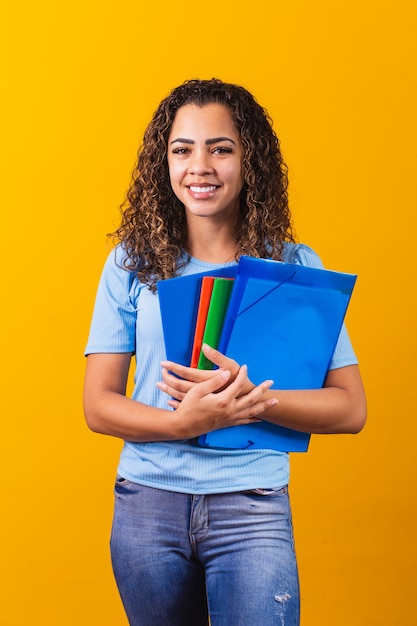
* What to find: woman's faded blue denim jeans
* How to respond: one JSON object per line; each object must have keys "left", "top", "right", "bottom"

{"left": 111, "top": 477, "right": 299, "bottom": 626}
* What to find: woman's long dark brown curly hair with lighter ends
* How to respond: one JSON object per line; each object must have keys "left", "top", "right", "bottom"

{"left": 111, "top": 78, "right": 294, "bottom": 291}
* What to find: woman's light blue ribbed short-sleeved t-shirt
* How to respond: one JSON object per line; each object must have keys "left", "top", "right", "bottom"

{"left": 85, "top": 243, "right": 357, "bottom": 494}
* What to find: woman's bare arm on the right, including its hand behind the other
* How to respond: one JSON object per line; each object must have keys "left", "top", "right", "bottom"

{"left": 161, "top": 346, "right": 366, "bottom": 434}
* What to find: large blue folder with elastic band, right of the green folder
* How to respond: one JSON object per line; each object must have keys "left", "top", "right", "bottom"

{"left": 200, "top": 257, "right": 356, "bottom": 452}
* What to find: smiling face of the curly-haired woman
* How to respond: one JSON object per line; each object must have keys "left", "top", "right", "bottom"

{"left": 168, "top": 103, "right": 243, "bottom": 220}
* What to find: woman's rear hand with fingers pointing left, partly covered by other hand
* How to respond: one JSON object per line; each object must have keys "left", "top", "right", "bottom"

{"left": 157, "top": 344, "right": 255, "bottom": 408}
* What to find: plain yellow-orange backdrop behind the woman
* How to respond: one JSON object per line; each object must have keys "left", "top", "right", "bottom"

{"left": 0, "top": 0, "right": 417, "bottom": 626}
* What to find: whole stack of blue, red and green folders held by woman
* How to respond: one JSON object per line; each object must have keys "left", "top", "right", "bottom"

{"left": 158, "top": 256, "right": 356, "bottom": 452}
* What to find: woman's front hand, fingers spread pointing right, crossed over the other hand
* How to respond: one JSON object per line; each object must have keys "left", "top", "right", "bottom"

{"left": 157, "top": 365, "right": 277, "bottom": 438}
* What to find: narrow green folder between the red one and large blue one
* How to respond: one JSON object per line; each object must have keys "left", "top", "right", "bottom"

{"left": 197, "top": 278, "right": 233, "bottom": 370}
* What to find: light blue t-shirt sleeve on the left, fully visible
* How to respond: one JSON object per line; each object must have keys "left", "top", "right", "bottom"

{"left": 85, "top": 247, "right": 137, "bottom": 355}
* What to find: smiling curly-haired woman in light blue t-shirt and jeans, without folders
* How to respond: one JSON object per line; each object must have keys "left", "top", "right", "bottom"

{"left": 84, "top": 79, "right": 366, "bottom": 626}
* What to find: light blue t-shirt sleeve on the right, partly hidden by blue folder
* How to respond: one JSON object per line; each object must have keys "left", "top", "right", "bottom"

{"left": 284, "top": 244, "right": 358, "bottom": 370}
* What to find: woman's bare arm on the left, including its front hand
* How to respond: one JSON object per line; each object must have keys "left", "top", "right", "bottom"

{"left": 84, "top": 353, "right": 276, "bottom": 441}
